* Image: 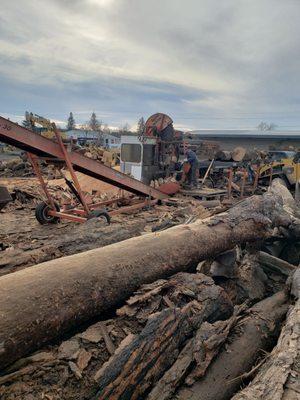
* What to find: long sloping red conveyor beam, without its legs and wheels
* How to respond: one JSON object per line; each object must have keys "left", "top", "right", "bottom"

{"left": 0, "top": 117, "right": 167, "bottom": 199}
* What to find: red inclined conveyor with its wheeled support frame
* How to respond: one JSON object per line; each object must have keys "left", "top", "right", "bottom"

{"left": 0, "top": 117, "right": 167, "bottom": 224}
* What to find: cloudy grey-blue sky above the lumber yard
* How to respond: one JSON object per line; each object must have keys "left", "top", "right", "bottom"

{"left": 0, "top": 0, "right": 300, "bottom": 130}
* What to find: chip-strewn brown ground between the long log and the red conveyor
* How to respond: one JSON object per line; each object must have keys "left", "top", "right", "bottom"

{"left": 0, "top": 178, "right": 210, "bottom": 276}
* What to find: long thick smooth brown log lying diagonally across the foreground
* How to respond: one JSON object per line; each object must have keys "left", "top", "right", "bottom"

{"left": 0, "top": 188, "right": 293, "bottom": 368}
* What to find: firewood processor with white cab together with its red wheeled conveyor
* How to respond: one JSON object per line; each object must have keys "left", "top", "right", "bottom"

{"left": 0, "top": 113, "right": 188, "bottom": 224}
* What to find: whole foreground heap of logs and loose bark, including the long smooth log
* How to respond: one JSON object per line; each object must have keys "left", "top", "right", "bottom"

{"left": 0, "top": 181, "right": 300, "bottom": 400}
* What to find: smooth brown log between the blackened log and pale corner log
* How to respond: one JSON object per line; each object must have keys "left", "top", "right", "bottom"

{"left": 176, "top": 292, "right": 288, "bottom": 400}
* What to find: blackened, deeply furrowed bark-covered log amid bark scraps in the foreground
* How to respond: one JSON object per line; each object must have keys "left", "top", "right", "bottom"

{"left": 95, "top": 274, "right": 232, "bottom": 400}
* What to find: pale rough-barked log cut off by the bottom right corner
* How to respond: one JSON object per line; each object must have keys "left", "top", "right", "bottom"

{"left": 232, "top": 269, "right": 300, "bottom": 400}
